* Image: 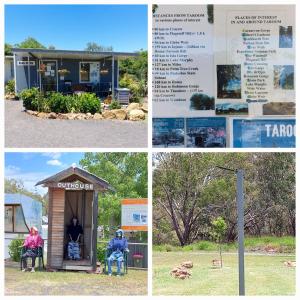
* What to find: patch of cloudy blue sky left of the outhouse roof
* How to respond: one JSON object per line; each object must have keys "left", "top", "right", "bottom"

{"left": 5, "top": 152, "right": 84, "bottom": 194}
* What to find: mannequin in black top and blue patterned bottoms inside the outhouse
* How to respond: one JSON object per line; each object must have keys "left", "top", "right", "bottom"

{"left": 67, "top": 216, "right": 83, "bottom": 260}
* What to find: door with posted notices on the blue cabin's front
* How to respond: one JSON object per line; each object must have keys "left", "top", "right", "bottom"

{"left": 39, "top": 60, "right": 58, "bottom": 92}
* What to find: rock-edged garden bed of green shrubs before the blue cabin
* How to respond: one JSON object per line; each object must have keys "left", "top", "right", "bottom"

{"left": 20, "top": 88, "right": 148, "bottom": 121}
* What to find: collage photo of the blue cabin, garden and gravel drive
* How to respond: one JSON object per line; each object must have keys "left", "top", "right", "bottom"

{"left": 4, "top": 3, "right": 148, "bottom": 148}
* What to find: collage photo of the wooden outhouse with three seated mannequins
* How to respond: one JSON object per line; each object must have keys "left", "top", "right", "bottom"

{"left": 4, "top": 152, "right": 148, "bottom": 296}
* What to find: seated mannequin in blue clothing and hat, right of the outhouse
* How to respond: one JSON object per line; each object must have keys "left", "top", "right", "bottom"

{"left": 107, "top": 229, "right": 129, "bottom": 276}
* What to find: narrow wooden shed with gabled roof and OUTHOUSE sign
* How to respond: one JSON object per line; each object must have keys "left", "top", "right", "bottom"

{"left": 36, "top": 167, "right": 113, "bottom": 271}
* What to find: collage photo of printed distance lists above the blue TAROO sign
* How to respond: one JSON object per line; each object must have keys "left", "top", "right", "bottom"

{"left": 152, "top": 4, "right": 295, "bottom": 148}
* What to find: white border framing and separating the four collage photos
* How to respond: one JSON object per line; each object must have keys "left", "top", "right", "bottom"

{"left": 0, "top": 0, "right": 300, "bottom": 300}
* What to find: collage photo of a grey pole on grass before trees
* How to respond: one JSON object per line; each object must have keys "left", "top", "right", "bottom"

{"left": 152, "top": 152, "right": 296, "bottom": 297}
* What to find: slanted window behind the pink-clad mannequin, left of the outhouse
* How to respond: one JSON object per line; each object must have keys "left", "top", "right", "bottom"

{"left": 4, "top": 205, "right": 28, "bottom": 233}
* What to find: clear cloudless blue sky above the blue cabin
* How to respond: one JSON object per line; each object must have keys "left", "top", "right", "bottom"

{"left": 5, "top": 5, "right": 148, "bottom": 52}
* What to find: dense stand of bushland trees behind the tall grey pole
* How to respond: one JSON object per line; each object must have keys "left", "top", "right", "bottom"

{"left": 153, "top": 153, "right": 295, "bottom": 245}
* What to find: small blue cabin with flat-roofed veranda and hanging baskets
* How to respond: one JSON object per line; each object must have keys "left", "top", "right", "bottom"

{"left": 12, "top": 48, "right": 138, "bottom": 99}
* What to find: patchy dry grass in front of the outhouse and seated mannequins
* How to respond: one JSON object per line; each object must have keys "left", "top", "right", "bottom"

{"left": 5, "top": 266, "right": 147, "bottom": 296}
